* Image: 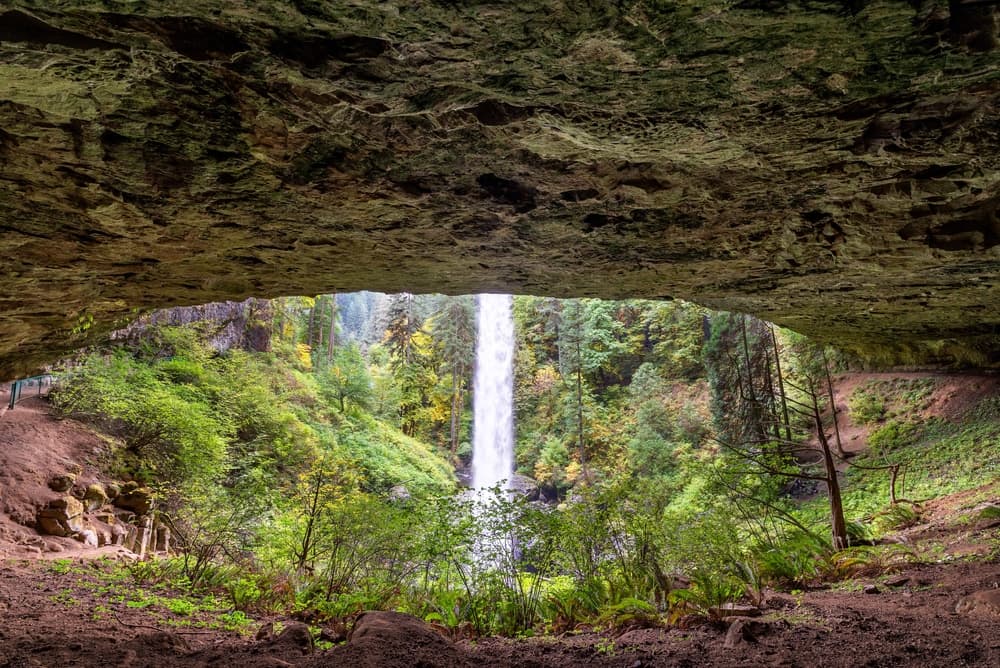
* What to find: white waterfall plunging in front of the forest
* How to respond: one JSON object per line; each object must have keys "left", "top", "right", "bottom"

{"left": 472, "top": 294, "right": 514, "bottom": 489}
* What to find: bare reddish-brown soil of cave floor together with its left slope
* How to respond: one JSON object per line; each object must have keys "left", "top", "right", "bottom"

{"left": 0, "top": 381, "right": 1000, "bottom": 668}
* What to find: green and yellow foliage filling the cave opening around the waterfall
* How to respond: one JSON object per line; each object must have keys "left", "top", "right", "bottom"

{"left": 51, "top": 296, "right": 1000, "bottom": 640}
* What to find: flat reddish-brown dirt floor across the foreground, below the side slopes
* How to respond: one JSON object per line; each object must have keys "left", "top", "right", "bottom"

{"left": 0, "top": 560, "right": 1000, "bottom": 668}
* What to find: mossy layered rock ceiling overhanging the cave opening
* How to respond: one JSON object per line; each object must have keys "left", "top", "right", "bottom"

{"left": 0, "top": 0, "right": 1000, "bottom": 376}
